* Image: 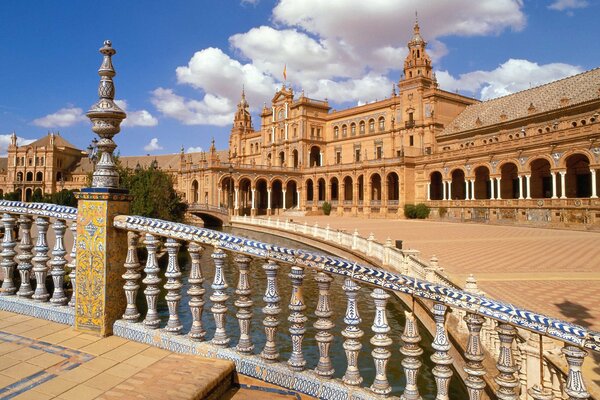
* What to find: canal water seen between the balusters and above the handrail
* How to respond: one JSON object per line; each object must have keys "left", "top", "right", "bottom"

{"left": 146, "top": 228, "right": 468, "bottom": 399}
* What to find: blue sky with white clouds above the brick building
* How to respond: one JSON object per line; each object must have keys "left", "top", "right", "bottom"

{"left": 0, "top": 0, "right": 600, "bottom": 155}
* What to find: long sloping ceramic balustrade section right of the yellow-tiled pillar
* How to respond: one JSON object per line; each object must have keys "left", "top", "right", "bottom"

{"left": 111, "top": 216, "right": 600, "bottom": 400}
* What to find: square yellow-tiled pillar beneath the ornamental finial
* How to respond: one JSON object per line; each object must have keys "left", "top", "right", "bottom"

{"left": 75, "top": 188, "right": 131, "bottom": 336}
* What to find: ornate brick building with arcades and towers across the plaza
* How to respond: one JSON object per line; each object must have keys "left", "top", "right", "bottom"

{"left": 0, "top": 24, "right": 600, "bottom": 225}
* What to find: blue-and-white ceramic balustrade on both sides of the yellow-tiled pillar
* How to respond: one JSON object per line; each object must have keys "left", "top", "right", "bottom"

{"left": 0, "top": 202, "right": 600, "bottom": 399}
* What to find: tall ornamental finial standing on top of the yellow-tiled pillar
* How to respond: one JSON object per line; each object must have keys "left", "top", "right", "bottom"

{"left": 86, "top": 40, "right": 127, "bottom": 189}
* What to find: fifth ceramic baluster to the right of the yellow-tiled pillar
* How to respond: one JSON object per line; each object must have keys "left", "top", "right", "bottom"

{"left": 210, "top": 247, "right": 230, "bottom": 347}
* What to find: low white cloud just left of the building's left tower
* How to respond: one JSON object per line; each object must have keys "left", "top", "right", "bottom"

{"left": 151, "top": 88, "right": 235, "bottom": 126}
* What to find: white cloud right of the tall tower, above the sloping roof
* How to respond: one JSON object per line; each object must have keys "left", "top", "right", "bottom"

{"left": 437, "top": 59, "right": 582, "bottom": 100}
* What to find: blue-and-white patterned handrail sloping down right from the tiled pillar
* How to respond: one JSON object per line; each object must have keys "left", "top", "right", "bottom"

{"left": 114, "top": 215, "right": 600, "bottom": 352}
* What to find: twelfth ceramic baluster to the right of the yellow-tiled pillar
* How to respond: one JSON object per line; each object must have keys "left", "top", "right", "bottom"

{"left": 400, "top": 311, "right": 423, "bottom": 400}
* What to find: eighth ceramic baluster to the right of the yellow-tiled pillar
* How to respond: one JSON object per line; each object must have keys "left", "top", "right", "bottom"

{"left": 288, "top": 265, "right": 308, "bottom": 371}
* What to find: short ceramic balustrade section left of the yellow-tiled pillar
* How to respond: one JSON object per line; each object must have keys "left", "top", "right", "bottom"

{"left": 0, "top": 200, "right": 77, "bottom": 322}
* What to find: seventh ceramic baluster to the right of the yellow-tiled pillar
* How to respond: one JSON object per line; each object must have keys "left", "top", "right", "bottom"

{"left": 260, "top": 260, "right": 281, "bottom": 362}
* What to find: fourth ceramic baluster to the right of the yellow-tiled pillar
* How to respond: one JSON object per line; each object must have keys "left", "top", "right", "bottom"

{"left": 187, "top": 242, "right": 206, "bottom": 341}
